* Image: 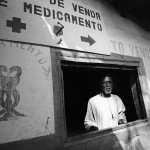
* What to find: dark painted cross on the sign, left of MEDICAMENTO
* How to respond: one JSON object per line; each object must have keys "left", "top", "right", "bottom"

{"left": 6, "top": 17, "right": 26, "bottom": 33}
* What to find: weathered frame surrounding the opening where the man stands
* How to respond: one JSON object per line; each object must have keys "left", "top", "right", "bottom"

{"left": 51, "top": 48, "right": 147, "bottom": 145}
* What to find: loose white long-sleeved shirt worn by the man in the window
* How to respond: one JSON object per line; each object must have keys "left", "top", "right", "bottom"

{"left": 84, "top": 94, "right": 126, "bottom": 130}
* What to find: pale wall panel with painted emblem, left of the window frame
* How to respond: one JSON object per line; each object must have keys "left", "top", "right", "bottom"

{"left": 0, "top": 40, "right": 55, "bottom": 143}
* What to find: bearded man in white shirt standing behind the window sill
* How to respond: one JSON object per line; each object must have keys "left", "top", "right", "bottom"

{"left": 84, "top": 75, "right": 127, "bottom": 131}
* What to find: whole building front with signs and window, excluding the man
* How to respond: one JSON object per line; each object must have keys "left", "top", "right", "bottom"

{"left": 0, "top": 0, "right": 150, "bottom": 150}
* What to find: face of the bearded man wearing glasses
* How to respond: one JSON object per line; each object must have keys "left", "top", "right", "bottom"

{"left": 102, "top": 76, "right": 112, "bottom": 95}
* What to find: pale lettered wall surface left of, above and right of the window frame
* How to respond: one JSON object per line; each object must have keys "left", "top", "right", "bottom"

{"left": 0, "top": 0, "right": 150, "bottom": 148}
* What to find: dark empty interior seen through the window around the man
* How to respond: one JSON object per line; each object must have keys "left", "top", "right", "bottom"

{"left": 61, "top": 61, "right": 143, "bottom": 137}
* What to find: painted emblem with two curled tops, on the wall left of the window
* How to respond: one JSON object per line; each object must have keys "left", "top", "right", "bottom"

{"left": 0, "top": 65, "right": 25, "bottom": 121}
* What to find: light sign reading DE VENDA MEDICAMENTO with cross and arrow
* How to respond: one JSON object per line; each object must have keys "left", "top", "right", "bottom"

{"left": 0, "top": 0, "right": 109, "bottom": 53}
